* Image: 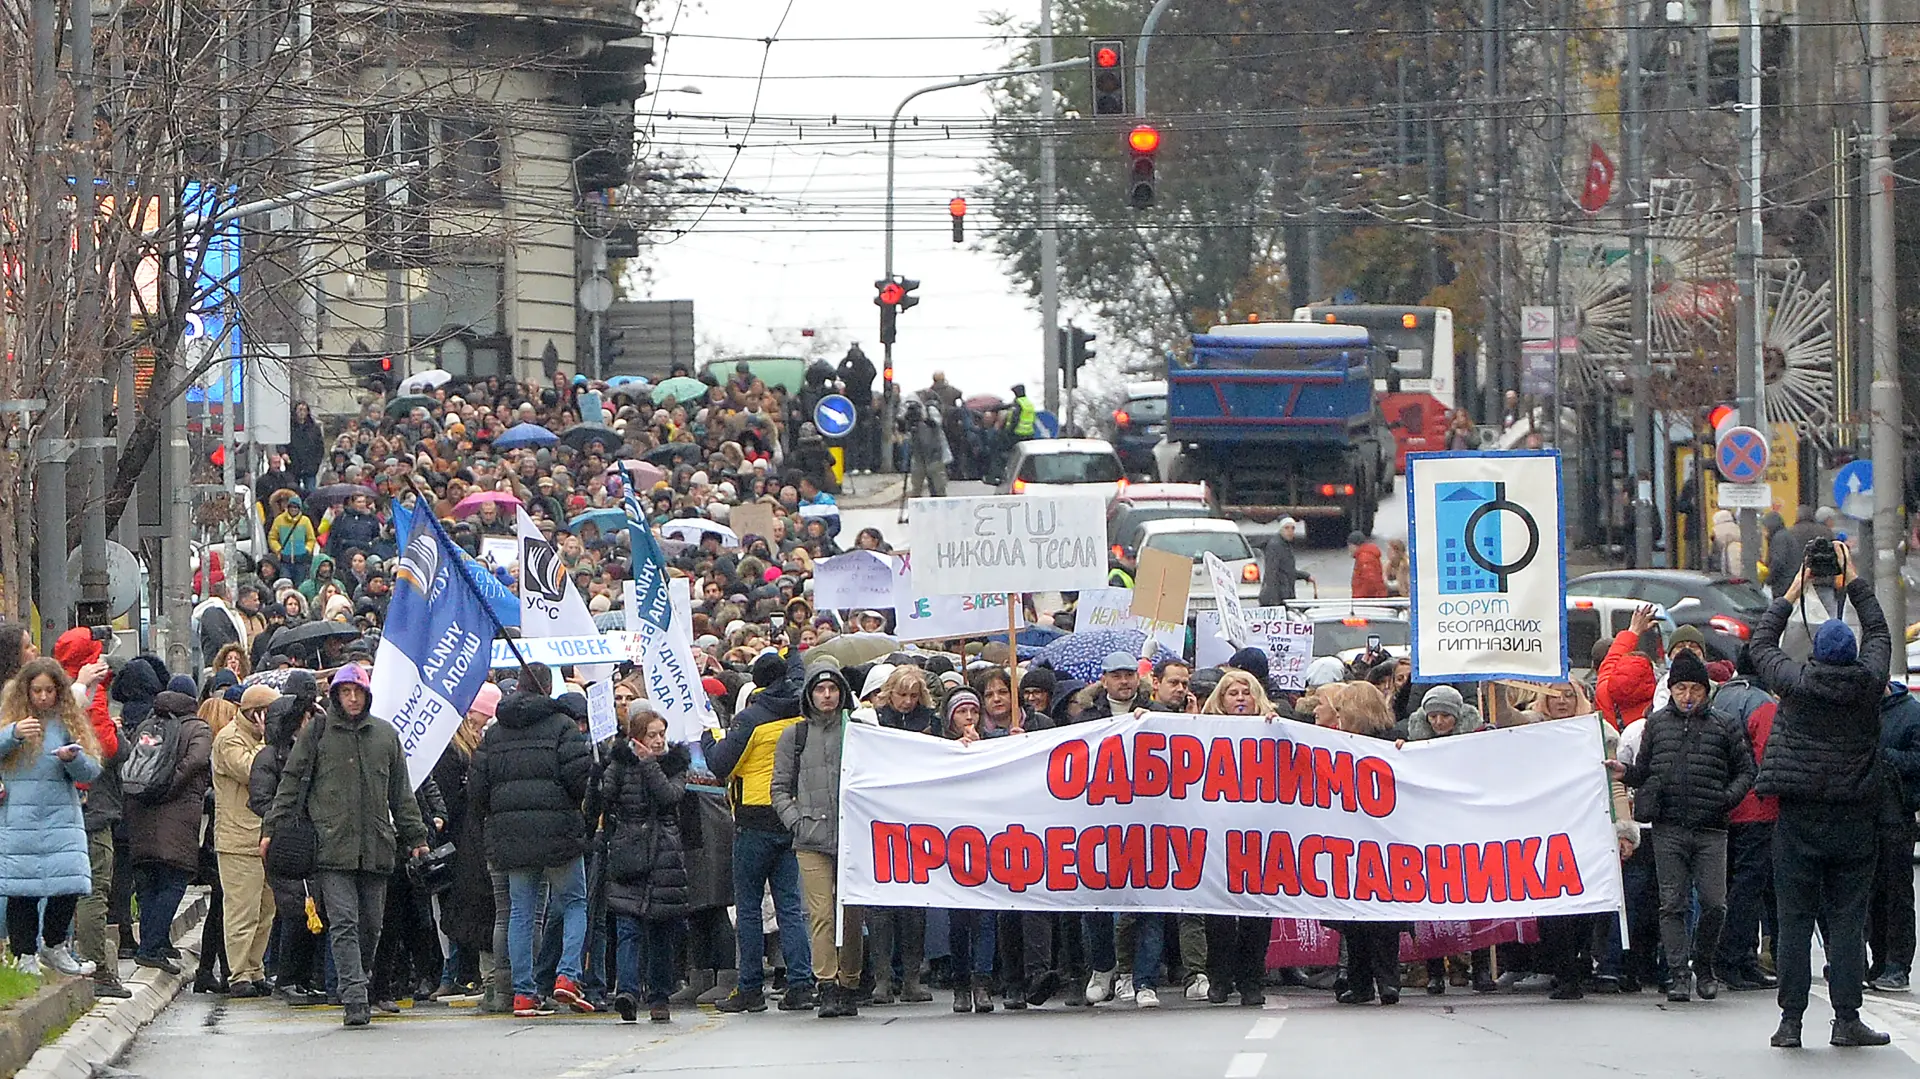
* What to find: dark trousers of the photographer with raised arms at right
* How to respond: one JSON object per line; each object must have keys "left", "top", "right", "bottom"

{"left": 1774, "top": 803, "right": 1878, "bottom": 1019}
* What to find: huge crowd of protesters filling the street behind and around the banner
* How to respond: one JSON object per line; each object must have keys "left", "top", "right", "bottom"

{"left": 0, "top": 357, "right": 1920, "bottom": 1046}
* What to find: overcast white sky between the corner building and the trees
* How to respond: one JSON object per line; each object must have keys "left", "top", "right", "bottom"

{"left": 637, "top": 0, "right": 1068, "bottom": 397}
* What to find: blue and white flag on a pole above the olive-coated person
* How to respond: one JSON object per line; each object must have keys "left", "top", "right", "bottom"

{"left": 372, "top": 499, "right": 495, "bottom": 787}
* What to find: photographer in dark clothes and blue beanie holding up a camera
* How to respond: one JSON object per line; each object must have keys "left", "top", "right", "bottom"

{"left": 1751, "top": 543, "right": 1893, "bottom": 1048}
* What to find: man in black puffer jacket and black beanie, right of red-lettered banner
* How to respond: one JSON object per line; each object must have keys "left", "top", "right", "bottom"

{"left": 1626, "top": 637, "right": 1753, "bottom": 1000}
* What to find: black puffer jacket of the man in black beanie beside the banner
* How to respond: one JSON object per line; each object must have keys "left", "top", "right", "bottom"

{"left": 1626, "top": 705, "right": 1753, "bottom": 827}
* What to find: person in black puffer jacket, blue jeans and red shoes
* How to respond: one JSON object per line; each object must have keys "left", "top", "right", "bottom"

{"left": 467, "top": 668, "right": 593, "bottom": 1016}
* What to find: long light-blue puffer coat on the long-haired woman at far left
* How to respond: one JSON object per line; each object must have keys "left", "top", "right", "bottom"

{"left": 0, "top": 716, "right": 100, "bottom": 897}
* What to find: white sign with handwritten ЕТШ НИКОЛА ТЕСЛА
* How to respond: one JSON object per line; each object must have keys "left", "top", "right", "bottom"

{"left": 906, "top": 493, "right": 1106, "bottom": 595}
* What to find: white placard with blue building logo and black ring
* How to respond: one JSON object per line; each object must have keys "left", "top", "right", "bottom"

{"left": 1407, "top": 449, "right": 1567, "bottom": 682}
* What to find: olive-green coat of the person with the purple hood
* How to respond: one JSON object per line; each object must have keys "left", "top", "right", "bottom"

{"left": 261, "top": 693, "right": 426, "bottom": 874}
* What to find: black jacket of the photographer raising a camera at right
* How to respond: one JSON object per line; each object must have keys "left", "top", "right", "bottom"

{"left": 1749, "top": 580, "right": 1893, "bottom": 804}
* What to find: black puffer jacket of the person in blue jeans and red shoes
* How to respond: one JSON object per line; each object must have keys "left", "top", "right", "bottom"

{"left": 467, "top": 693, "right": 593, "bottom": 870}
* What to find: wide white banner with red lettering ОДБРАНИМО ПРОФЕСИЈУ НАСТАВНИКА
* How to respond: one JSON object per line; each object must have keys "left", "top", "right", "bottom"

{"left": 839, "top": 712, "right": 1622, "bottom": 922}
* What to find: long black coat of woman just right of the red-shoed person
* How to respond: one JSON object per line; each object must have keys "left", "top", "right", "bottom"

{"left": 601, "top": 739, "right": 693, "bottom": 920}
